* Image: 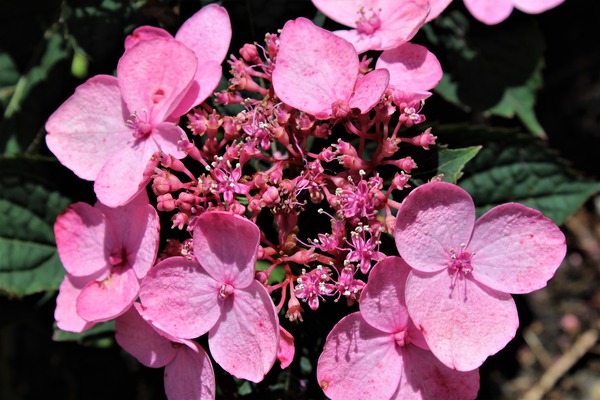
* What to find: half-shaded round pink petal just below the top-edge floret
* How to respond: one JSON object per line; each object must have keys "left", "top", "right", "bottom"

{"left": 376, "top": 43, "right": 443, "bottom": 93}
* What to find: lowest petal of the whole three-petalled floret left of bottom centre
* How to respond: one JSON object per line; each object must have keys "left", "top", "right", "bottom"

{"left": 208, "top": 281, "right": 279, "bottom": 382}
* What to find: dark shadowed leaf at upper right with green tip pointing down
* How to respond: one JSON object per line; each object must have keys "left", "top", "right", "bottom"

{"left": 425, "top": 11, "right": 545, "bottom": 137}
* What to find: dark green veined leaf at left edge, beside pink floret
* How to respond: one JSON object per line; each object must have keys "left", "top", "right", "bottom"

{"left": 0, "top": 158, "right": 71, "bottom": 296}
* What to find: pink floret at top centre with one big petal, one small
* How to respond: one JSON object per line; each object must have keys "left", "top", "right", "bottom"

{"left": 273, "top": 18, "right": 389, "bottom": 119}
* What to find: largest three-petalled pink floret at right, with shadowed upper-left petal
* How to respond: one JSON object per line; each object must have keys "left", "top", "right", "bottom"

{"left": 395, "top": 182, "right": 566, "bottom": 371}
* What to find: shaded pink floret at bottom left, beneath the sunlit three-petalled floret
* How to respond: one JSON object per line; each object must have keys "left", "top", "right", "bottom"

{"left": 115, "top": 303, "right": 215, "bottom": 400}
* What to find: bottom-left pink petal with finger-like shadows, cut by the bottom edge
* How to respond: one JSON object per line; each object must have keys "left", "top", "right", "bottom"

{"left": 317, "top": 312, "right": 403, "bottom": 400}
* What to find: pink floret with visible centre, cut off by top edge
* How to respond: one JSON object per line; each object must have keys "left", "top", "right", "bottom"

{"left": 312, "top": 0, "right": 430, "bottom": 54}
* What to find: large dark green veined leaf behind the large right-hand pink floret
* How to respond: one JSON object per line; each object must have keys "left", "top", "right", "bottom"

{"left": 436, "top": 126, "right": 600, "bottom": 225}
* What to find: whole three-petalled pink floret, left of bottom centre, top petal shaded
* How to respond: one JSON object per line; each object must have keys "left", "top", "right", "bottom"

{"left": 140, "top": 212, "right": 279, "bottom": 382}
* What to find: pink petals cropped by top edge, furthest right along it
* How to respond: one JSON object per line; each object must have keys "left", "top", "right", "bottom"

{"left": 464, "top": 0, "right": 564, "bottom": 25}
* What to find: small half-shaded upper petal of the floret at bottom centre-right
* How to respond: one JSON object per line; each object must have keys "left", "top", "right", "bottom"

{"left": 360, "top": 257, "right": 410, "bottom": 334}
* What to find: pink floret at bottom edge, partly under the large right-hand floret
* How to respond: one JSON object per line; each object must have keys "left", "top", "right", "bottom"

{"left": 317, "top": 257, "right": 479, "bottom": 400}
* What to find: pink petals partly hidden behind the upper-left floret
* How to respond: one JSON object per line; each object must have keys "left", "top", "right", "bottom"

{"left": 125, "top": 4, "right": 232, "bottom": 109}
